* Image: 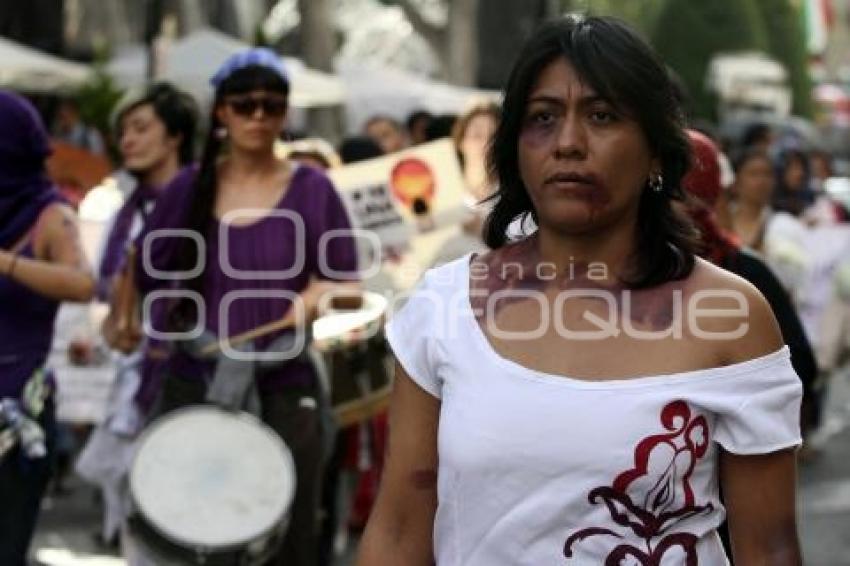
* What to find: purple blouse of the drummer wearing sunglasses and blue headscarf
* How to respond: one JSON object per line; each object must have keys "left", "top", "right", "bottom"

{"left": 137, "top": 165, "right": 357, "bottom": 407}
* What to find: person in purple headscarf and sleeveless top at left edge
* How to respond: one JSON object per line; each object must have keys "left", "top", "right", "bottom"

{"left": 0, "top": 91, "right": 94, "bottom": 566}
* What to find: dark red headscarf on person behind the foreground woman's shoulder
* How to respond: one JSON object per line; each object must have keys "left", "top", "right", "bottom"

{"left": 682, "top": 130, "right": 741, "bottom": 264}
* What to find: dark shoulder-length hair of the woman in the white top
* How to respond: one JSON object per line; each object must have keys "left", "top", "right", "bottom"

{"left": 484, "top": 15, "right": 698, "bottom": 288}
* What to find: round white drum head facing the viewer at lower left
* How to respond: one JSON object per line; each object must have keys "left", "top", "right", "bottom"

{"left": 130, "top": 406, "right": 295, "bottom": 549}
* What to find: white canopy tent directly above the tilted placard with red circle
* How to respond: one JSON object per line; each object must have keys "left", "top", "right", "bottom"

{"left": 337, "top": 60, "right": 501, "bottom": 132}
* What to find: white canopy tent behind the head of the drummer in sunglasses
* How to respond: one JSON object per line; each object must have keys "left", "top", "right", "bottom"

{"left": 107, "top": 29, "right": 345, "bottom": 108}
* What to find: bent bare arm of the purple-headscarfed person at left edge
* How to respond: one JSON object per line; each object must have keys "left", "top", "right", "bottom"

{"left": 0, "top": 205, "right": 94, "bottom": 303}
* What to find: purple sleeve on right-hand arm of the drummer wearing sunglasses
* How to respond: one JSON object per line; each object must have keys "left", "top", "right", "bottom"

{"left": 308, "top": 172, "right": 360, "bottom": 281}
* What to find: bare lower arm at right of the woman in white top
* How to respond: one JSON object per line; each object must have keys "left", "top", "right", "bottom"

{"left": 720, "top": 450, "right": 802, "bottom": 566}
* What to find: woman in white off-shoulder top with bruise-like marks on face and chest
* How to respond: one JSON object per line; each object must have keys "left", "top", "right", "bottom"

{"left": 358, "top": 17, "right": 801, "bottom": 566}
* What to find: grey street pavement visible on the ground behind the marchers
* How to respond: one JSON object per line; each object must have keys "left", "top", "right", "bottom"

{"left": 33, "top": 370, "right": 850, "bottom": 566}
